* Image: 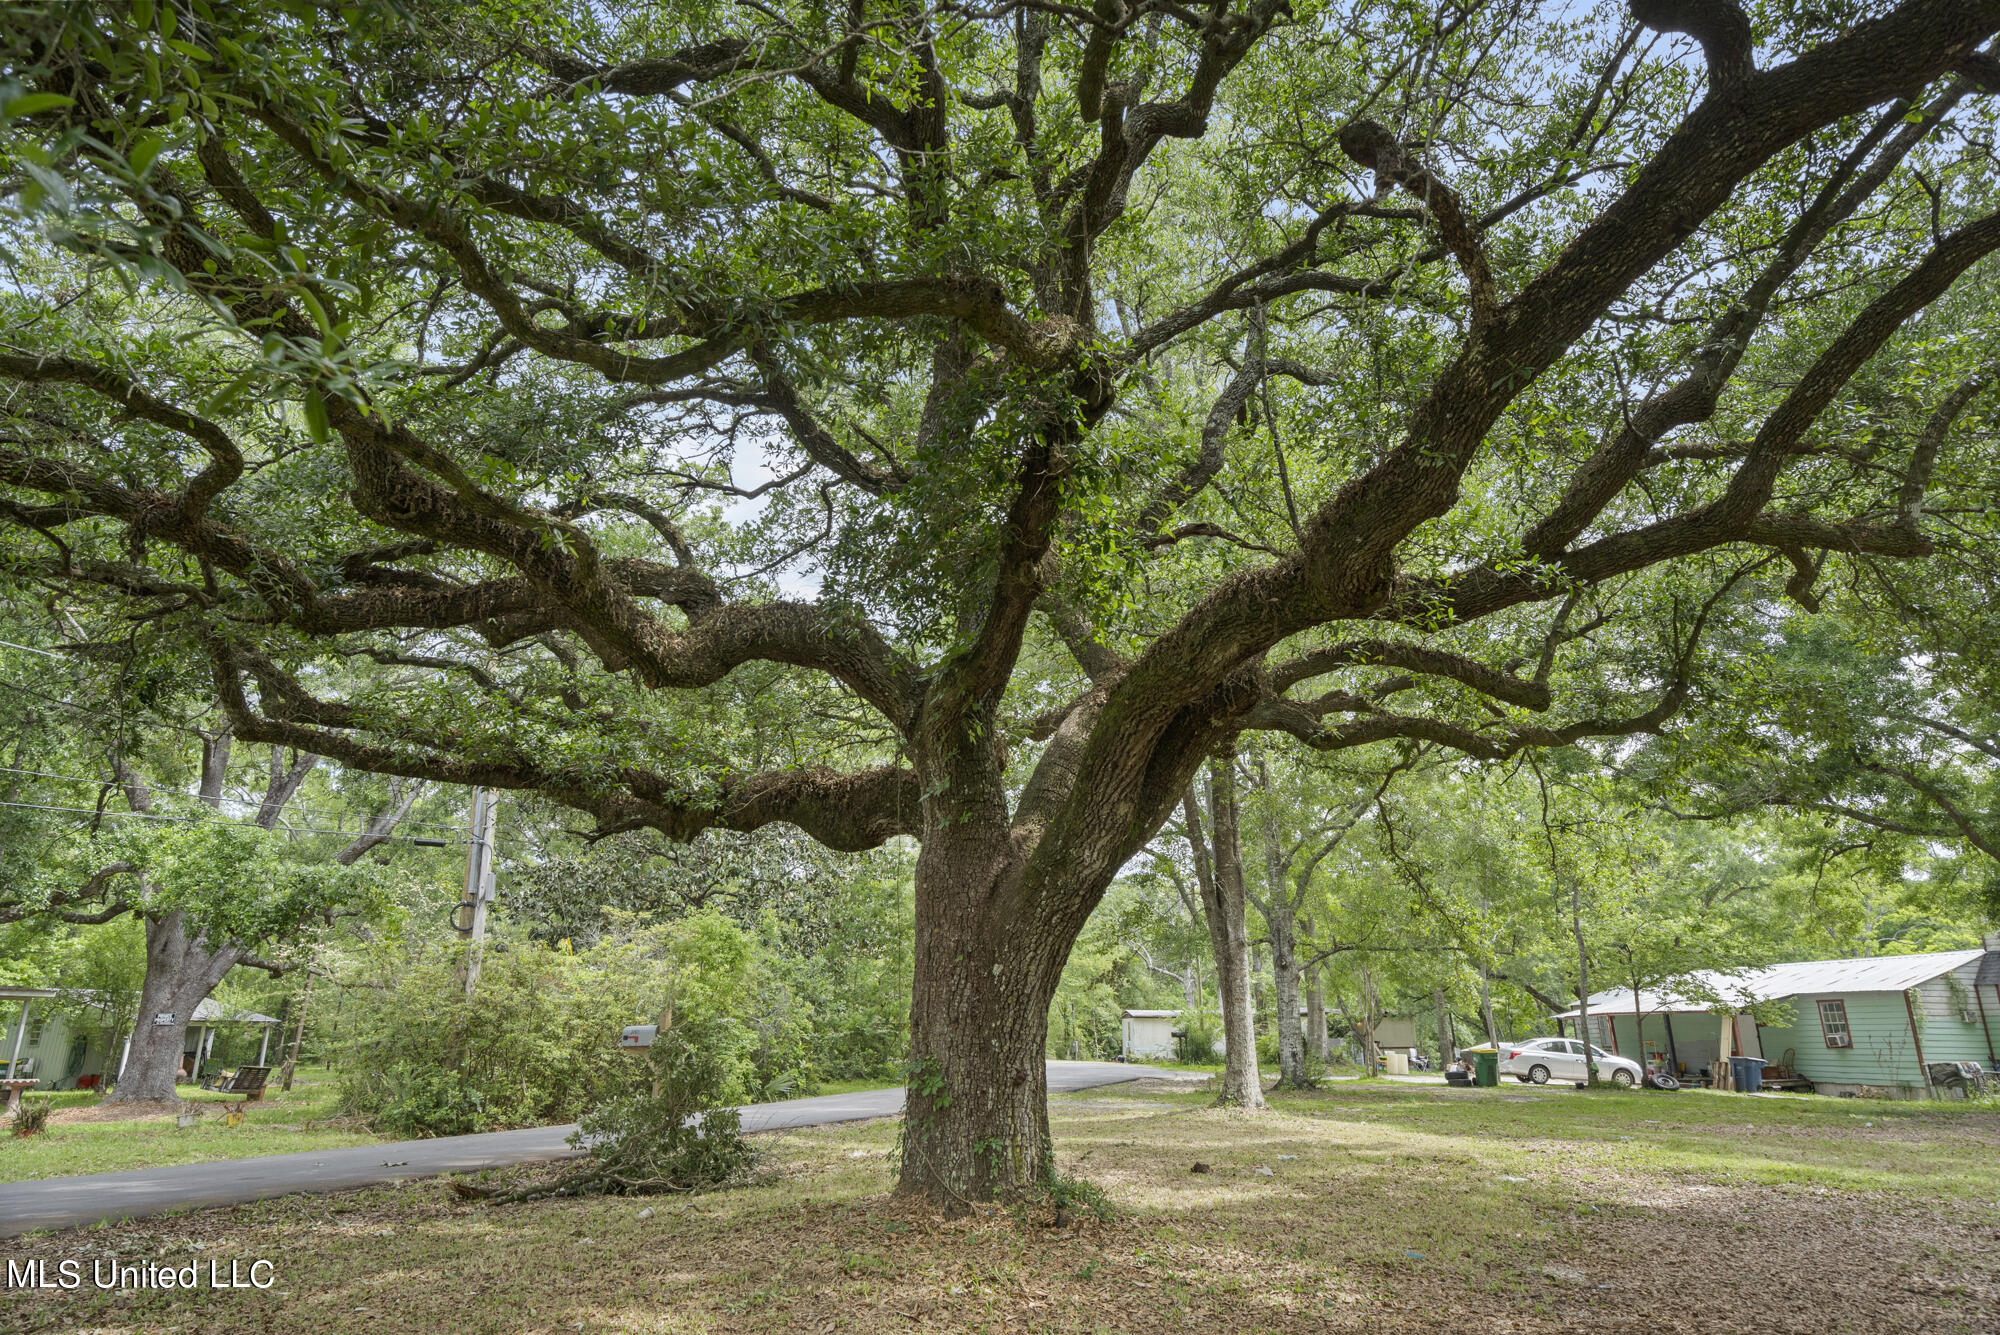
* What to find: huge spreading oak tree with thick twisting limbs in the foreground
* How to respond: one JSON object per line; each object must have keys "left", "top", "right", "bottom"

{"left": 0, "top": 0, "right": 2000, "bottom": 1203}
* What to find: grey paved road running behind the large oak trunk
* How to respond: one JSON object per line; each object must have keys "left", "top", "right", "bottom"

{"left": 0, "top": 1061, "right": 1176, "bottom": 1237}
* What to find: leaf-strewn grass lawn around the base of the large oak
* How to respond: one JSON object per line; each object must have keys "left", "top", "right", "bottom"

{"left": 0, "top": 1081, "right": 2000, "bottom": 1335}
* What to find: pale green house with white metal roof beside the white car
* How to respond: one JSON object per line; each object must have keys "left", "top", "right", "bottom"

{"left": 1556, "top": 935, "right": 2000, "bottom": 1099}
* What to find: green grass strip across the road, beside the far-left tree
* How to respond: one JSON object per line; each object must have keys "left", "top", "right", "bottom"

{"left": 0, "top": 1067, "right": 382, "bottom": 1181}
